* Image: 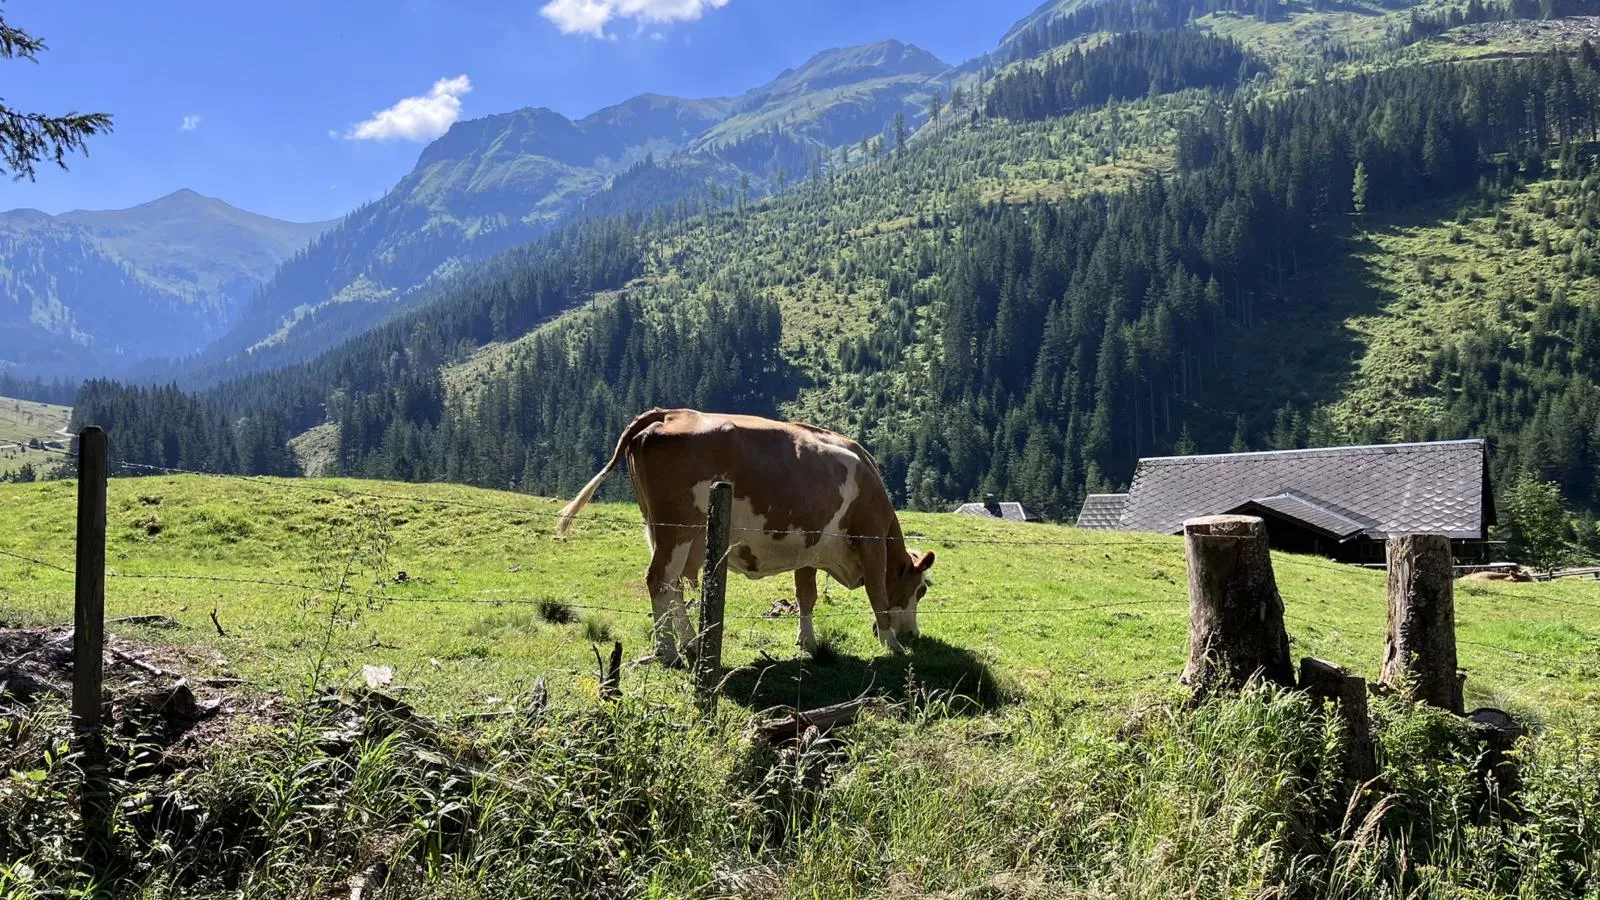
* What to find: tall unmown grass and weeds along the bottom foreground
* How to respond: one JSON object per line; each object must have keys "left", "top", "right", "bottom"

{"left": 0, "top": 690, "right": 1600, "bottom": 897}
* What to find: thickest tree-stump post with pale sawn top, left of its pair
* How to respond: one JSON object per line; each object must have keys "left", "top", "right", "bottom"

{"left": 1182, "top": 516, "right": 1294, "bottom": 693}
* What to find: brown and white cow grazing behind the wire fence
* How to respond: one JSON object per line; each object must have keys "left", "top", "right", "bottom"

{"left": 557, "top": 410, "right": 933, "bottom": 665}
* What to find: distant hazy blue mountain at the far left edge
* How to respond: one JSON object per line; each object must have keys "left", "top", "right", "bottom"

{"left": 0, "top": 191, "right": 331, "bottom": 375}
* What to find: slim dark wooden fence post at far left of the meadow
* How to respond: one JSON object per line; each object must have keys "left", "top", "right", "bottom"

{"left": 72, "top": 426, "right": 112, "bottom": 860}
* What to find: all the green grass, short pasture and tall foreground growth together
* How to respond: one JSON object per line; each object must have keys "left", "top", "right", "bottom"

{"left": 0, "top": 476, "right": 1600, "bottom": 900}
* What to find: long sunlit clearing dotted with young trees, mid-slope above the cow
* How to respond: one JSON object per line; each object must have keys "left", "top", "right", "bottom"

{"left": 446, "top": 93, "right": 1200, "bottom": 441}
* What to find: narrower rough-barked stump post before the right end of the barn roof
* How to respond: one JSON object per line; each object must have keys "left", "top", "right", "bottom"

{"left": 1382, "top": 535, "right": 1462, "bottom": 716}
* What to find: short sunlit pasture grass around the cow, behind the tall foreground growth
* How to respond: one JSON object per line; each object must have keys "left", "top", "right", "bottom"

{"left": 0, "top": 477, "right": 1600, "bottom": 714}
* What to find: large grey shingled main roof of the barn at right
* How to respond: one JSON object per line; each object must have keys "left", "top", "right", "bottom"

{"left": 1120, "top": 440, "right": 1494, "bottom": 540}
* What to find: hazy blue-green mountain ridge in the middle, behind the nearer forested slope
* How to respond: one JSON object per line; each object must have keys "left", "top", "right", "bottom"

{"left": 159, "top": 40, "right": 950, "bottom": 384}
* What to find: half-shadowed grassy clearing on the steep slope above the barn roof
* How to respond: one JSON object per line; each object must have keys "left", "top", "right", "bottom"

{"left": 1232, "top": 174, "right": 1600, "bottom": 439}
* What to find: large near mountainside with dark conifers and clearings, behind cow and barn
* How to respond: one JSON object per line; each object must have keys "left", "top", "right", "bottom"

{"left": 80, "top": 0, "right": 1600, "bottom": 554}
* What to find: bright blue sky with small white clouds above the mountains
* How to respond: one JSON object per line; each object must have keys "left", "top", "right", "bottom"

{"left": 0, "top": 0, "right": 1038, "bottom": 221}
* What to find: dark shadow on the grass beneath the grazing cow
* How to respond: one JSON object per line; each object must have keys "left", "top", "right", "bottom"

{"left": 723, "top": 637, "right": 1014, "bottom": 714}
